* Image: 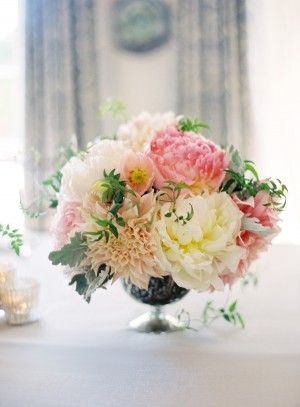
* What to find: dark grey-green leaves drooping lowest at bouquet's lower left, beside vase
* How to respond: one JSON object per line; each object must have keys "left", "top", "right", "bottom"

{"left": 69, "top": 264, "right": 112, "bottom": 303}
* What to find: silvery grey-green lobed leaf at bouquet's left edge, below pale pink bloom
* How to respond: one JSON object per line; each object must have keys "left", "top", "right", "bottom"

{"left": 49, "top": 232, "right": 87, "bottom": 267}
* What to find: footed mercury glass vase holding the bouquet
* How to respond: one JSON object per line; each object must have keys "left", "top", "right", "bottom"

{"left": 122, "top": 276, "right": 189, "bottom": 333}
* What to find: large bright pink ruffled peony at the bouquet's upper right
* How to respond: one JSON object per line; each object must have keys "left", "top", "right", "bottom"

{"left": 148, "top": 127, "right": 228, "bottom": 191}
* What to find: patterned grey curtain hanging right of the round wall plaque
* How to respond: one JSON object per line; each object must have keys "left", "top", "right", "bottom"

{"left": 175, "top": 0, "right": 250, "bottom": 153}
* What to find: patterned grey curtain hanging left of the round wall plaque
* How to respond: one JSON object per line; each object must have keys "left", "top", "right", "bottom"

{"left": 25, "top": 0, "right": 100, "bottom": 230}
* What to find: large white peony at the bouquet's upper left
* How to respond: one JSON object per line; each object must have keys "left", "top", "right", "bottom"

{"left": 59, "top": 140, "right": 127, "bottom": 203}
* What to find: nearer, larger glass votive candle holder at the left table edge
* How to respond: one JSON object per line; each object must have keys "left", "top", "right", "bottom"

{"left": 0, "top": 278, "right": 40, "bottom": 325}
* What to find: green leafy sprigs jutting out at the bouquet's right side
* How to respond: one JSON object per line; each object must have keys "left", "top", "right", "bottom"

{"left": 220, "top": 146, "right": 288, "bottom": 211}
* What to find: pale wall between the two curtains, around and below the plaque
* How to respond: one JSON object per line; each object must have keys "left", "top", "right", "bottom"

{"left": 98, "top": 0, "right": 176, "bottom": 118}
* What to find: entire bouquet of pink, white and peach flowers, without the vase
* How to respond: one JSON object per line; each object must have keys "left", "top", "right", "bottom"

{"left": 49, "top": 113, "right": 286, "bottom": 318}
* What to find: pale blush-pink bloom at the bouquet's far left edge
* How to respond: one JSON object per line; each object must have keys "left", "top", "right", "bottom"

{"left": 55, "top": 202, "right": 84, "bottom": 247}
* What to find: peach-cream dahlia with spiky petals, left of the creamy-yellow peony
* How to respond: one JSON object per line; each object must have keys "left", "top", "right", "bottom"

{"left": 82, "top": 192, "right": 167, "bottom": 289}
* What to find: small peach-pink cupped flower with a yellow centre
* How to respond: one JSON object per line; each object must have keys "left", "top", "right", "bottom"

{"left": 121, "top": 151, "right": 154, "bottom": 195}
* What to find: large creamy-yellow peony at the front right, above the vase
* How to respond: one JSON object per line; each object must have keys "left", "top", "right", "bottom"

{"left": 156, "top": 193, "right": 244, "bottom": 291}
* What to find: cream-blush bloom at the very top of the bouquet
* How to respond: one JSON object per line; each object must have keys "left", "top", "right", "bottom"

{"left": 117, "top": 112, "right": 180, "bottom": 151}
